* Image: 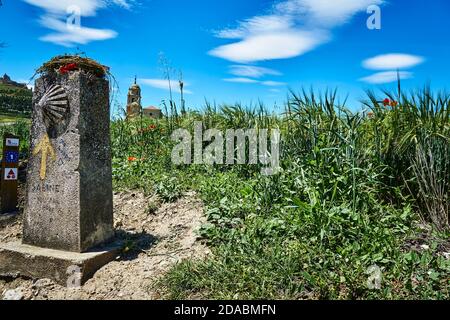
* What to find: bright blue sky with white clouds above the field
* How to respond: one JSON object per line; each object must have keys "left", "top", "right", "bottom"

{"left": 0, "top": 0, "right": 450, "bottom": 115}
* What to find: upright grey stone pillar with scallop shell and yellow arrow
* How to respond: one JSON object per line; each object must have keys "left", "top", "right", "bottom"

{"left": 23, "top": 71, "right": 114, "bottom": 252}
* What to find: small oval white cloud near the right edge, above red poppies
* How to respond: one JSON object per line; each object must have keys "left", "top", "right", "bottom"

{"left": 363, "top": 53, "right": 425, "bottom": 70}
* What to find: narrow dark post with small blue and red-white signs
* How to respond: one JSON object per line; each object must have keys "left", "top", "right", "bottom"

{"left": 0, "top": 134, "right": 20, "bottom": 214}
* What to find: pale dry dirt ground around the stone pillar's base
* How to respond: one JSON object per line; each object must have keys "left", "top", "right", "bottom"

{"left": 0, "top": 192, "right": 210, "bottom": 300}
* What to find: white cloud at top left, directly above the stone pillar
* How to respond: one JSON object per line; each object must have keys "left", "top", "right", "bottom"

{"left": 22, "top": 0, "right": 134, "bottom": 47}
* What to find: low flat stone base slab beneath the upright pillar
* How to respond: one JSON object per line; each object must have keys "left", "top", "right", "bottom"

{"left": 0, "top": 242, "right": 121, "bottom": 286}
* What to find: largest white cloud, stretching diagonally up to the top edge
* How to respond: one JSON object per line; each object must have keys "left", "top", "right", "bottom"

{"left": 209, "top": 0, "right": 384, "bottom": 63}
